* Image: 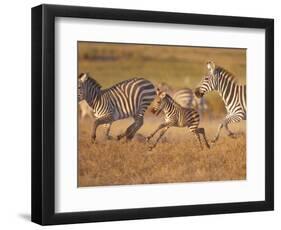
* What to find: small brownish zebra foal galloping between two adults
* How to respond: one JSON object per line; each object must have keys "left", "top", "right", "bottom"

{"left": 146, "top": 89, "right": 210, "bottom": 150}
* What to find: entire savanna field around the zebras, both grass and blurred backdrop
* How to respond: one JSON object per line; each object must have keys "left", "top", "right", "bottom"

{"left": 78, "top": 42, "right": 246, "bottom": 187}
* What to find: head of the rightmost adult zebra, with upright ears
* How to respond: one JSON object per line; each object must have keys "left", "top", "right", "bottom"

{"left": 195, "top": 61, "right": 218, "bottom": 98}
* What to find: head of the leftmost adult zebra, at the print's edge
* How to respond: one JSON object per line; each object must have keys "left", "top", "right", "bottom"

{"left": 77, "top": 73, "right": 101, "bottom": 105}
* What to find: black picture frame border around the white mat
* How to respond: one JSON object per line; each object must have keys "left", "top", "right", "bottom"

{"left": 31, "top": 5, "right": 274, "bottom": 225}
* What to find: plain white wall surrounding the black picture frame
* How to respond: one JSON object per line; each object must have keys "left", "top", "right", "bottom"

{"left": 0, "top": 0, "right": 276, "bottom": 230}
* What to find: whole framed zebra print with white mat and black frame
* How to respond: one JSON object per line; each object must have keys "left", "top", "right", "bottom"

{"left": 32, "top": 5, "right": 274, "bottom": 225}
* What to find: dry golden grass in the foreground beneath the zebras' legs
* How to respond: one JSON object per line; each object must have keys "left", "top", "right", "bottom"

{"left": 78, "top": 117, "right": 246, "bottom": 186}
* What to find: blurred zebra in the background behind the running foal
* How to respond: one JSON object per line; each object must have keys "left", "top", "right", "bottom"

{"left": 173, "top": 88, "right": 208, "bottom": 117}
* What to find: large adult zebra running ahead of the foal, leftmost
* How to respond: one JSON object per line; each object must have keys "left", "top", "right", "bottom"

{"left": 78, "top": 73, "right": 156, "bottom": 143}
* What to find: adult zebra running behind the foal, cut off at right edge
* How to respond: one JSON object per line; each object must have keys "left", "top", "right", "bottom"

{"left": 195, "top": 61, "right": 247, "bottom": 143}
